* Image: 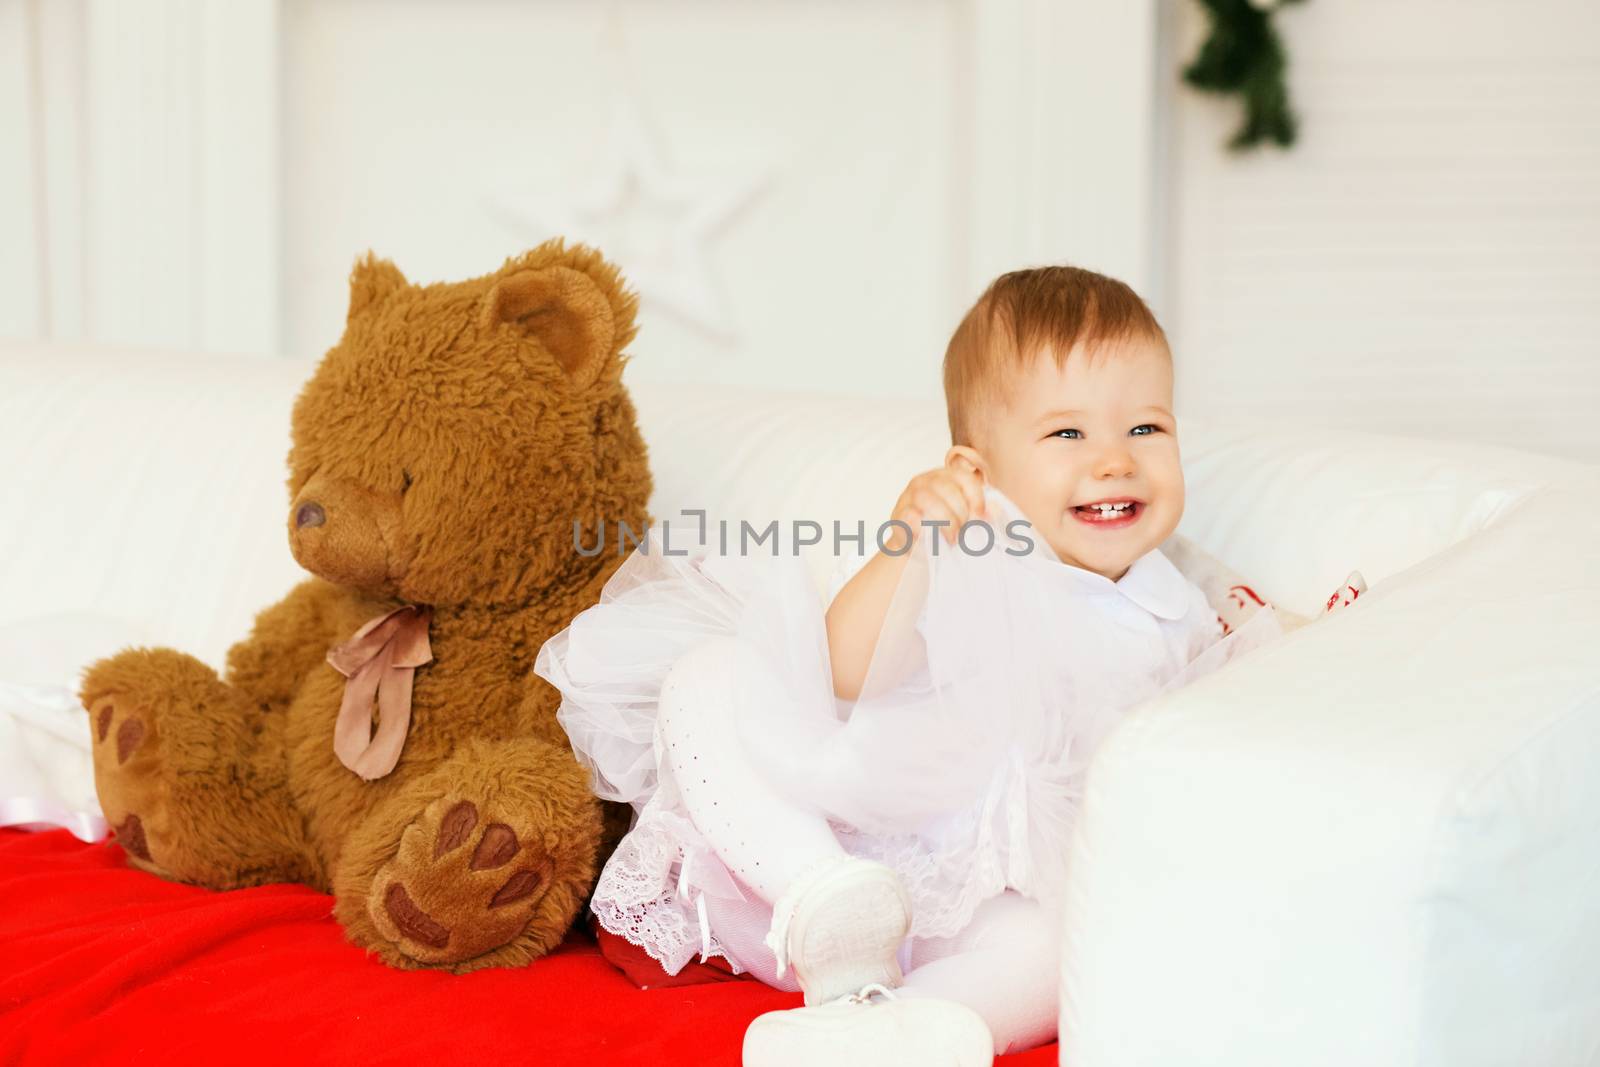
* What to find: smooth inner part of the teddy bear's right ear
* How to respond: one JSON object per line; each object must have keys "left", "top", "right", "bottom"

{"left": 480, "top": 267, "right": 618, "bottom": 387}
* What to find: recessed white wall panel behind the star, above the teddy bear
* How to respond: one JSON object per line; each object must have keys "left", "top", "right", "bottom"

{"left": 285, "top": 0, "right": 963, "bottom": 396}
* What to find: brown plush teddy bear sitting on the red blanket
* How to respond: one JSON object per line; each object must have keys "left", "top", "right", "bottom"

{"left": 82, "top": 240, "right": 651, "bottom": 971}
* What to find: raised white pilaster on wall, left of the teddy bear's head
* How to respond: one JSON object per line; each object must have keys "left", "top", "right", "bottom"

{"left": 83, "top": 0, "right": 280, "bottom": 354}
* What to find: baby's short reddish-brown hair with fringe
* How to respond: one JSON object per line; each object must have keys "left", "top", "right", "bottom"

{"left": 944, "top": 267, "right": 1166, "bottom": 445}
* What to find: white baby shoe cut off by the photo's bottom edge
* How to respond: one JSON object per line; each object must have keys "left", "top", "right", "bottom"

{"left": 744, "top": 985, "right": 994, "bottom": 1067}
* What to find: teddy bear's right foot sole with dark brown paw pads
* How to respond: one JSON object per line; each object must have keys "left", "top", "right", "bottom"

{"left": 366, "top": 797, "right": 550, "bottom": 966}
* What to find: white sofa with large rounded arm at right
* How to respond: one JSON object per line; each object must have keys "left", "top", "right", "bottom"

{"left": 0, "top": 347, "right": 1600, "bottom": 1067}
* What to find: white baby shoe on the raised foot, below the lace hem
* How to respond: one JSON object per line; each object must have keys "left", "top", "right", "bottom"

{"left": 766, "top": 856, "right": 910, "bottom": 1005}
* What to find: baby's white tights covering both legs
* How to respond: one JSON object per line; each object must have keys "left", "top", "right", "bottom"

{"left": 656, "top": 638, "right": 1059, "bottom": 1054}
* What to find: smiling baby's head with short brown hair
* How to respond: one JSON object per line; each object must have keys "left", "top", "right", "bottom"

{"left": 944, "top": 266, "right": 1184, "bottom": 581}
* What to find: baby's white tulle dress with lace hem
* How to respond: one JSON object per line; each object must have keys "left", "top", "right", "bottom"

{"left": 534, "top": 488, "right": 1283, "bottom": 987}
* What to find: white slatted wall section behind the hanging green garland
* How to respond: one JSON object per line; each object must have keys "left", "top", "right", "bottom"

{"left": 1163, "top": 0, "right": 1600, "bottom": 461}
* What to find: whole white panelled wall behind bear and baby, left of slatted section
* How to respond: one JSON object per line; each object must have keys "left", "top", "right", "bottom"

{"left": 9, "top": 0, "right": 1155, "bottom": 394}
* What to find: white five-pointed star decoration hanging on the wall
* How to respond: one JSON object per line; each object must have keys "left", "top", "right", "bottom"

{"left": 490, "top": 91, "right": 766, "bottom": 339}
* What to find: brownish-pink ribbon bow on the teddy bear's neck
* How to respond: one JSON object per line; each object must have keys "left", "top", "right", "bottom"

{"left": 328, "top": 605, "right": 434, "bottom": 781}
